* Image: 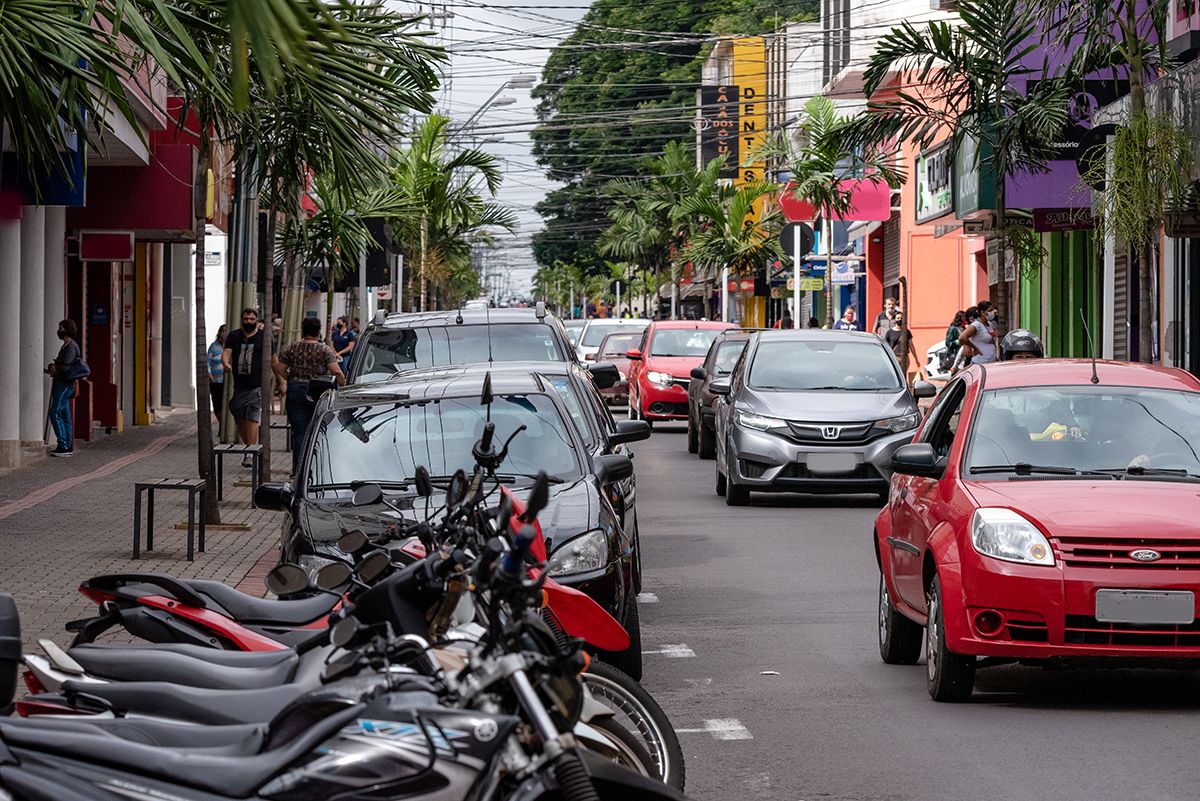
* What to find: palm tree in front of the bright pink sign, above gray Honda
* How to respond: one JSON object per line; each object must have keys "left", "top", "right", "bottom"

{"left": 755, "top": 96, "right": 904, "bottom": 326}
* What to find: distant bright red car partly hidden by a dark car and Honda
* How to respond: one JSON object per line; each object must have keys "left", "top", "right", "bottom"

{"left": 625, "top": 320, "right": 737, "bottom": 424}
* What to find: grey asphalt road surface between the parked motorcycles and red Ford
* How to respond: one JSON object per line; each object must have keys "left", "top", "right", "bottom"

{"left": 635, "top": 426, "right": 1200, "bottom": 801}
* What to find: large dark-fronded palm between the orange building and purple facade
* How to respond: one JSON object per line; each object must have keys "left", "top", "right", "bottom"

{"left": 842, "top": 0, "right": 1073, "bottom": 328}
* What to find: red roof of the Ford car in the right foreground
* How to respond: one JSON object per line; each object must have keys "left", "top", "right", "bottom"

{"left": 970, "top": 359, "right": 1200, "bottom": 392}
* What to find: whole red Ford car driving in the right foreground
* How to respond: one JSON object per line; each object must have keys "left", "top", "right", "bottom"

{"left": 875, "top": 360, "right": 1200, "bottom": 701}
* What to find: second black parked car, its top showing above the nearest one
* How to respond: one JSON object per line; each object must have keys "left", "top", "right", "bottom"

{"left": 346, "top": 303, "right": 620, "bottom": 389}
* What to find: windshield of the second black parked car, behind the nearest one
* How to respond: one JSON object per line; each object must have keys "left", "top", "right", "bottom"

{"left": 355, "top": 323, "right": 565, "bottom": 381}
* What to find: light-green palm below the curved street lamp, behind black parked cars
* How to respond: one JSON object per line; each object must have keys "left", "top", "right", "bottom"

{"left": 391, "top": 114, "right": 517, "bottom": 312}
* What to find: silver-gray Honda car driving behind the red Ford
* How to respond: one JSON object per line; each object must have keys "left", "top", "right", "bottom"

{"left": 709, "top": 330, "right": 935, "bottom": 506}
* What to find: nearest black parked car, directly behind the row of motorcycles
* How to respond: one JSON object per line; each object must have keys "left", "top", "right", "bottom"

{"left": 256, "top": 366, "right": 647, "bottom": 677}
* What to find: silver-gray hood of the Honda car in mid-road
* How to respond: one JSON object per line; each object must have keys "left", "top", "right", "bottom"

{"left": 737, "top": 387, "right": 917, "bottom": 423}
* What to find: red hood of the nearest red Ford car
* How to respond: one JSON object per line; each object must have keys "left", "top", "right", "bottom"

{"left": 966, "top": 480, "right": 1200, "bottom": 540}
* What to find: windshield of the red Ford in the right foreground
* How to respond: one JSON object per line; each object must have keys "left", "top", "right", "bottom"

{"left": 964, "top": 386, "right": 1200, "bottom": 480}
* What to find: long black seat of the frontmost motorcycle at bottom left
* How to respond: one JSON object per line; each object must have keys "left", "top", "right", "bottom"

{"left": 0, "top": 705, "right": 362, "bottom": 799}
